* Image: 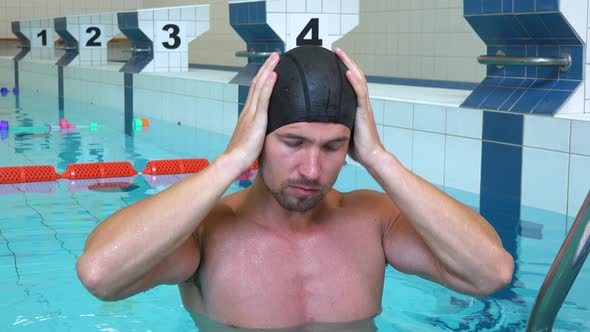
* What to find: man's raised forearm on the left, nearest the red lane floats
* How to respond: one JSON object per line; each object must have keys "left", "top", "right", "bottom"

{"left": 78, "top": 153, "right": 243, "bottom": 296}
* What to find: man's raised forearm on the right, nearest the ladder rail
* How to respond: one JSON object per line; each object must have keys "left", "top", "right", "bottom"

{"left": 367, "top": 151, "right": 511, "bottom": 294}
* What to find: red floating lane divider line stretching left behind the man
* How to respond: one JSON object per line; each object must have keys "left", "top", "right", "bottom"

{"left": 0, "top": 158, "right": 258, "bottom": 184}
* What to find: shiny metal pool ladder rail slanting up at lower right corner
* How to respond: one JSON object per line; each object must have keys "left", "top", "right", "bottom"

{"left": 527, "top": 192, "right": 590, "bottom": 332}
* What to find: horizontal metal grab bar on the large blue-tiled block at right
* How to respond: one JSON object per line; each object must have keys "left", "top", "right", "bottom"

{"left": 477, "top": 51, "right": 572, "bottom": 72}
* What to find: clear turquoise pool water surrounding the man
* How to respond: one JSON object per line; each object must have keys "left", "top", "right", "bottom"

{"left": 0, "top": 91, "right": 590, "bottom": 331}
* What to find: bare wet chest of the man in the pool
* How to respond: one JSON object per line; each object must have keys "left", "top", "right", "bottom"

{"left": 198, "top": 226, "right": 385, "bottom": 326}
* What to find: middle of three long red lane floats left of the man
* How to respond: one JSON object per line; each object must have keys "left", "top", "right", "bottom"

{"left": 61, "top": 161, "right": 137, "bottom": 180}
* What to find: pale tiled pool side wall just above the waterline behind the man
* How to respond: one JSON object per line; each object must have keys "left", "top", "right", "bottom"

{"left": 0, "top": 59, "right": 590, "bottom": 229}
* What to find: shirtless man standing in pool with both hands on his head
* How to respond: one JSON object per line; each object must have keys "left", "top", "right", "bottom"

{"left": 77, "top": 49, "right": 513, "bottom": 330}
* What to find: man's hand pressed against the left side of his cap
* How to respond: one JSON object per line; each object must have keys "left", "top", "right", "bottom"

{"left": 225, "top": 53, "right": 279, "bottom": 171}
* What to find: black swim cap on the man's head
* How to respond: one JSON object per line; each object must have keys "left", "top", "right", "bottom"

{"left": 266, "top": 46, "right": 357, "bottom": 134}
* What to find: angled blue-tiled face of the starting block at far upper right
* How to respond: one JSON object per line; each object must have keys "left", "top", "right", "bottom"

{"left": 461, "top": 10, "right": 585, "bottom": 115}
